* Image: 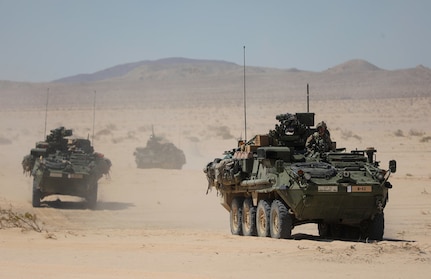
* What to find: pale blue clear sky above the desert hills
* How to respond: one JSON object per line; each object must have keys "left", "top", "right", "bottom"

{"left": 0, "top": 0, "right": 431, "bottom": 82}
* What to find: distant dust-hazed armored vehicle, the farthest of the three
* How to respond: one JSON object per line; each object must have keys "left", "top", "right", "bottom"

{"left": 133, "top": 130, "right": 186, "bottom": 169}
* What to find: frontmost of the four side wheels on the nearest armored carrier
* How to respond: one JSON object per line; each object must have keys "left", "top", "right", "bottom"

{"left": 269, "top": 200, "right": 292, "bottom": 238}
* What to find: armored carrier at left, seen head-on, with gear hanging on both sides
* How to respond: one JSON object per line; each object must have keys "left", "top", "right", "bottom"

{"left": 22, "top": 127, "right": 112, "bottom": 208}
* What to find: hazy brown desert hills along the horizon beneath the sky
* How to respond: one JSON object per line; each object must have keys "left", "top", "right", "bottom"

{"left": 0, "top": 58, "right": 431, "bottom": 109}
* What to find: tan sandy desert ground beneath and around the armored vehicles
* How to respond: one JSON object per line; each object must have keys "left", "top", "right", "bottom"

{"left": 0, "top": 98, "right": 431, "bottom": 278}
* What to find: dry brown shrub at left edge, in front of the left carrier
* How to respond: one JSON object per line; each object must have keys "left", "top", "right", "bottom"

{"left": 0, "top": 208, "right": 42, "bottom": 232}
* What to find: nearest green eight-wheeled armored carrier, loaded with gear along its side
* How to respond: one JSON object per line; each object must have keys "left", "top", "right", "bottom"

{"left": 204, "top": 113, "right": 396, "bottom": 240}
